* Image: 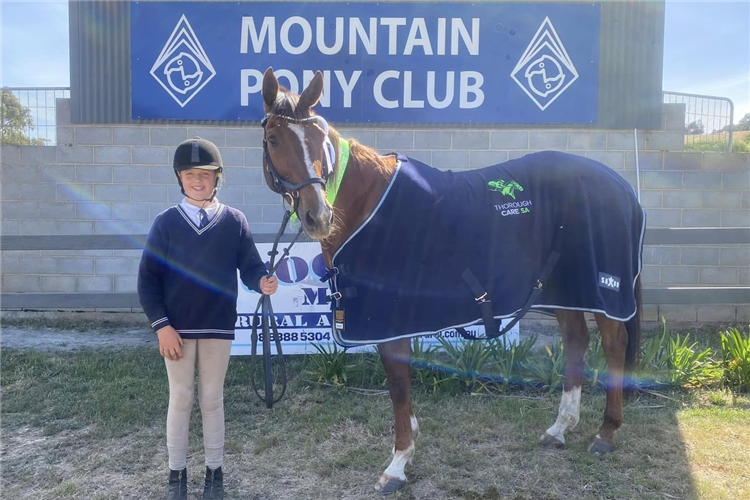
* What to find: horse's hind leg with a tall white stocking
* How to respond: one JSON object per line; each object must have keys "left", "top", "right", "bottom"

{"left": 539, "top": 309, "right": 589, "bottom": 448}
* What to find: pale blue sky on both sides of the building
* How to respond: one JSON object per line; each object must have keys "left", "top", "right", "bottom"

{"left": 0, "top": 0, "right": 750, "bottom": 122}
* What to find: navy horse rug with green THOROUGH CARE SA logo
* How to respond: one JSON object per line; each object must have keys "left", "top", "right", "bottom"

{"left": 330, "top": 151, "right": 645, "bottom": 346}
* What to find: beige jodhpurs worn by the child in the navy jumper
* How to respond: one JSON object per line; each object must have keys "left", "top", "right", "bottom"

{"left": 164, "top": 339, "right": 232, "bottom": 470}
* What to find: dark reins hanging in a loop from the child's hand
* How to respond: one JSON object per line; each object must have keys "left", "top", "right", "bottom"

{"left": 250, "top": 210, "right": 302, "bottom": 408}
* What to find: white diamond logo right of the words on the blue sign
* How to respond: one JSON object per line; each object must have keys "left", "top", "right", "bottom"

{"left": 510, "top": 17, "right": 578, "bottom": 111}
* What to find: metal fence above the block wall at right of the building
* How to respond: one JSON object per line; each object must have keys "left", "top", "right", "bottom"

{"left": 662, "top": 92, "right": 734, "bottom": 151}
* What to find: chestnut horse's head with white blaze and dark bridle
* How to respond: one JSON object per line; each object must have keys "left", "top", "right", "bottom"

{"left": 262, "top": 68, "right": 336, "bottom": 240}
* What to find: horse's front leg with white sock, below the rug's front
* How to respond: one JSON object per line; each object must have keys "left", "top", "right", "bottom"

{"left": 375, "top": 339, "right": 419, "bottom": 495}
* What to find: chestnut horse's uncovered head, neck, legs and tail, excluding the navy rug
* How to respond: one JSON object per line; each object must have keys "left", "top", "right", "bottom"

{"left": 262, "top": 68, "right": 640, "bottom": 494}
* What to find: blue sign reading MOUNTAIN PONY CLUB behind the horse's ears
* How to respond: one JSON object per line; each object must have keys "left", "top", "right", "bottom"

{"left": 130, "top": 2, "right": 600, "bottom": 124}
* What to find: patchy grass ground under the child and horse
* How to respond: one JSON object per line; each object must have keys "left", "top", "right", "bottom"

{"left": 0, "top": 348, "right": 750, "bottom": 500}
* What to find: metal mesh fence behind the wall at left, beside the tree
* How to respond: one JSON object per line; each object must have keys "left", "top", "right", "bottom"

{"left": 0, "top": 87, "right": 70, "bottom": 146}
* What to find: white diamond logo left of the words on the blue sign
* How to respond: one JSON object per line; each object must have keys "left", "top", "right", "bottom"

{"left": 151, "top": 14, "right": 216, "bottom": 107}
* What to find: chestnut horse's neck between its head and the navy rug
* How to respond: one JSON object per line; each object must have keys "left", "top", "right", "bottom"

{"left": 321, "top": 128, "right": 396, "bottom": 267}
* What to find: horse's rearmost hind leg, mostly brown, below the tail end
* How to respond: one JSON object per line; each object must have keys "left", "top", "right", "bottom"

{"left": 589, "top": 314, "right": 628, "bottom": 455}
